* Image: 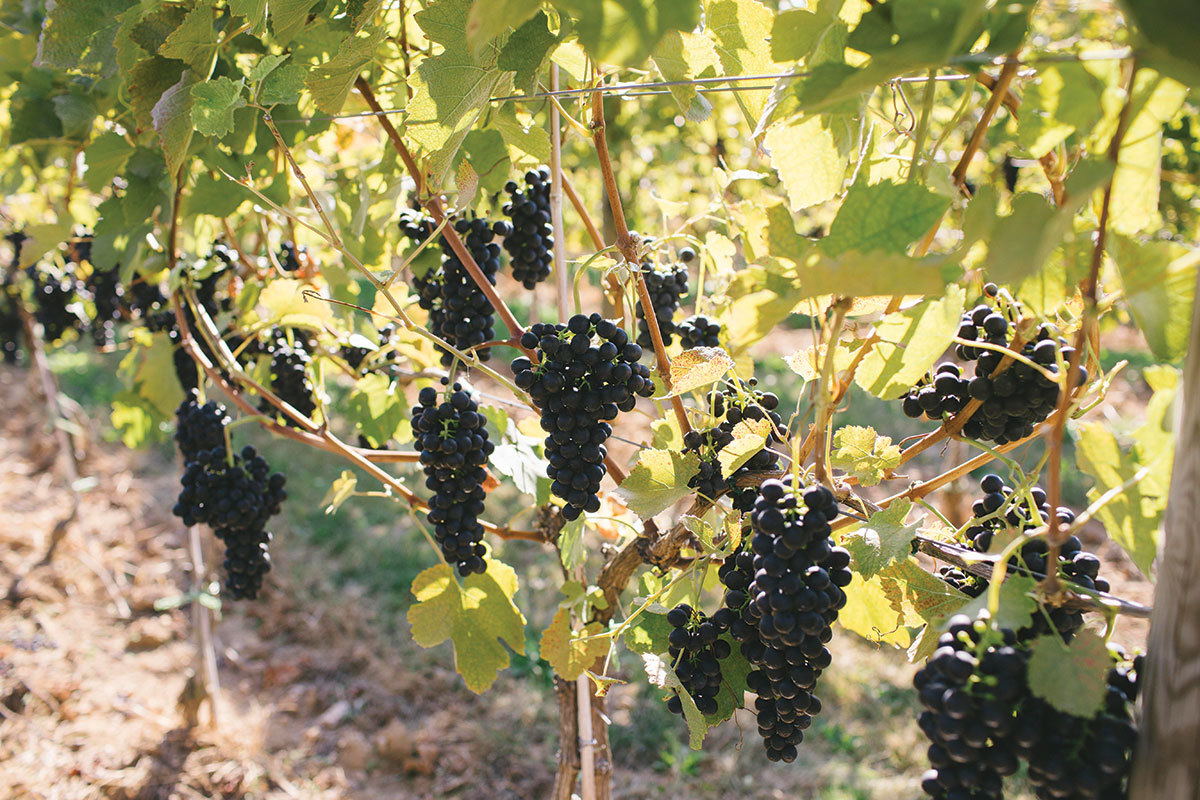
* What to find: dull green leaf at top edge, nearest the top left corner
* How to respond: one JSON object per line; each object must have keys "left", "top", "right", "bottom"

{"left": 34, "top": 0, "right": 133, "bottom": 77}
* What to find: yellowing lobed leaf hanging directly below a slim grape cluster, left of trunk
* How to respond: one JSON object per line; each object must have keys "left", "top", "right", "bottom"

{"left": 408, "top": 559, "right": 526, "bottom": 694}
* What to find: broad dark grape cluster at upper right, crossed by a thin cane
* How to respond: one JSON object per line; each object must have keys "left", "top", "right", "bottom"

{"left": 904, "top": 292, "right": 1087, "bottom": 445}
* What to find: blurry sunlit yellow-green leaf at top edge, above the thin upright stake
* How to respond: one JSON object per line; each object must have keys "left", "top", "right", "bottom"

{"left": 553, "top": 0, "right": 700, "bottom": 67}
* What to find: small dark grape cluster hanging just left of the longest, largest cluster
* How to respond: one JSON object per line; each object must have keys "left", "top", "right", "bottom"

{"left": 667, "top": 603, "right": 733, "bottom": 715}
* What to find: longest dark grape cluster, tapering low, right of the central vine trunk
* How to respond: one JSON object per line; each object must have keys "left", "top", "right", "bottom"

{"left": 719, "top": 477, "right": 851, "bottom": 762}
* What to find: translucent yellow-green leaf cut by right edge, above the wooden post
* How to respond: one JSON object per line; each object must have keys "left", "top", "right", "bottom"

{"left": 1110, "top": 236, "right": 1200, "bottom": 362}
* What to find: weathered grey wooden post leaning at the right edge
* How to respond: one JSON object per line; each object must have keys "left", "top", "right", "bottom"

{"left": 1129, "top": 267, "right": 1200, "bottom": 800}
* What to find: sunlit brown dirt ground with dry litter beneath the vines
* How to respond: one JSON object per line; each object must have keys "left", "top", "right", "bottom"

{"left": 0, "top": 359, "right": 1150, "bottom": 800}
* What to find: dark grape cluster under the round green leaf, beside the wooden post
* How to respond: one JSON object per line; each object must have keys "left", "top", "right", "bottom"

{"left": 1018, "top": 650, "right": 1144, "bottom": 800}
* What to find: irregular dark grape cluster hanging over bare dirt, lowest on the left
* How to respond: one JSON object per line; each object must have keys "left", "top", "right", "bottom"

{"left": 173, "top": 392, "right": 287, "bottom": 600}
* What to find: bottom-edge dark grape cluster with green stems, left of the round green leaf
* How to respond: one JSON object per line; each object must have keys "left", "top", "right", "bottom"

{"left": 913, "top": 614, "right": 1028, "bottom": 800}
